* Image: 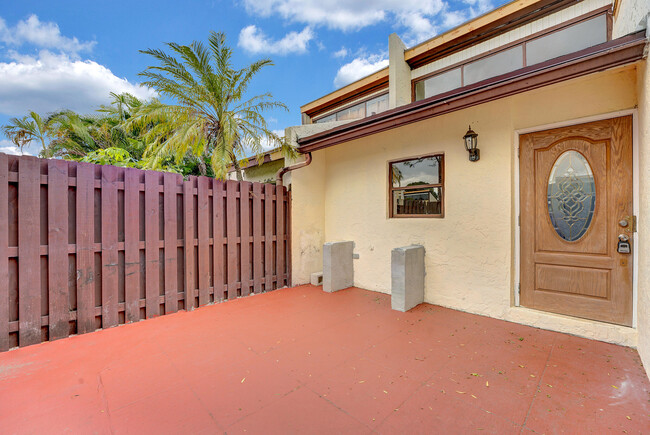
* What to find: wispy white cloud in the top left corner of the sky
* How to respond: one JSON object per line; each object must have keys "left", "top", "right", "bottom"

{"left": 0, "top": 15, "right": 95, "bottom": 56}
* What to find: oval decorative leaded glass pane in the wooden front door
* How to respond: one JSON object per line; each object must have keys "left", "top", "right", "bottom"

{"left": 547, "top": 151, "right": 596, "bottom": 242}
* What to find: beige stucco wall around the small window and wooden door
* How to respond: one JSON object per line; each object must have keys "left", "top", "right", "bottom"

{"left": 292, "top": 66, "right": 650, "bottom": 346}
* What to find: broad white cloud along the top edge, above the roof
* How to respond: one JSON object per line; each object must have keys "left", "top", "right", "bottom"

{"left": 239, "top": 0, "right": 480, "bottom": 43}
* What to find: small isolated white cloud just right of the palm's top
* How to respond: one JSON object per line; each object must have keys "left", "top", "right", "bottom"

{"left": 238, "top": 25, "right": 314, "bottom": 55}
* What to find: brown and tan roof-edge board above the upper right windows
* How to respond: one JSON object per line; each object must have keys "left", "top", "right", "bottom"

{"left": 404, "top": 0, "right": 583, "bottom": 69}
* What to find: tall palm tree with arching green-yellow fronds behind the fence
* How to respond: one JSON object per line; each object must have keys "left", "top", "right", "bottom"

{"left": 126, "top": 32, "right": 295, "bottom": 180}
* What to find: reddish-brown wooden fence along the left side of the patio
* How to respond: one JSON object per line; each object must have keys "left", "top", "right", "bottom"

{"left": 0, "top": 154, "right": 290, "bottom": 351}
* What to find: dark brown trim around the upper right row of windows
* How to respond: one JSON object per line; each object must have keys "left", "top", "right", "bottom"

{"left": 411, "top": 5, "right": 612, "bottom": 102}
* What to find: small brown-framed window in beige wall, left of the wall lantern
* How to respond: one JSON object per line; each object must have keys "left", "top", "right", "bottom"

{"left": 388, "top": 154, "right": 444, "bottom": 218}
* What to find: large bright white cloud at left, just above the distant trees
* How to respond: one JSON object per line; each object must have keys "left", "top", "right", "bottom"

{"left": 0, "top": 50, "right": 156, "bottom": 116}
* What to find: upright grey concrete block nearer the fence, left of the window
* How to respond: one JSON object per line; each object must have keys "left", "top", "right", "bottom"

{"left": 323, "top": 241, "right": 354, "bottom": 293}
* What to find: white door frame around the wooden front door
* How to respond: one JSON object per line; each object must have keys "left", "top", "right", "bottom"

{"left": 512, "top": 108, "right": 639, "bottom": 329}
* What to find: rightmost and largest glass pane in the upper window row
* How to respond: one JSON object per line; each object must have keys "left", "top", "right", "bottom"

{"left": 526, "top": 15, "right": 607, "bottom": 65}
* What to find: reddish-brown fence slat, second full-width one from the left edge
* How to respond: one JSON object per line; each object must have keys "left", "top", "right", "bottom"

{"left": 47, "top": 160, "right": 70, "bottom": 340}
